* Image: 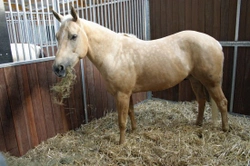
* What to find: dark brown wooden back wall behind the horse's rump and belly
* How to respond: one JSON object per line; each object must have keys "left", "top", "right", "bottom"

{"left": 149, "top": 0, "right": 250, "bottom": 115}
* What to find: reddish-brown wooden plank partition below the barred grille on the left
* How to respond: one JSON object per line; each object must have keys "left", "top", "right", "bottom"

{"left": 0, "top": 58, "right": 146, "bottom": 156}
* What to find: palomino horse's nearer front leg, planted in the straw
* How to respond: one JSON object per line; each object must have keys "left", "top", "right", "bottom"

{"left": 116, "top": 92, "right": 131, "bottom": 144}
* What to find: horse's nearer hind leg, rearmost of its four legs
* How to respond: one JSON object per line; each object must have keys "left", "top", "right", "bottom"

{"left": 207, "top": 84, "right": 229, "bottom": 131}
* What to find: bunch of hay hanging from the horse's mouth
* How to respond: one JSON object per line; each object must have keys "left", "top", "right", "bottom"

{"left": 50, "top": 67, "right": 76, "bottom": 105}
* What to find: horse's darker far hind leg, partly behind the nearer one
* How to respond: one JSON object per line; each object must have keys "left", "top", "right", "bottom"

{"left": 189, "top": 77, "right": 206, "bottom": 126}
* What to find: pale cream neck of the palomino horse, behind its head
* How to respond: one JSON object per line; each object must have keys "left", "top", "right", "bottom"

{"left": 80, "top": 20, "right": 119, "bottom": 68}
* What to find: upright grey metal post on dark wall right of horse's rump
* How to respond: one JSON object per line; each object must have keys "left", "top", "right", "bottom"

{"left": 229, "top": 0, "right": 241, "bottom": 112}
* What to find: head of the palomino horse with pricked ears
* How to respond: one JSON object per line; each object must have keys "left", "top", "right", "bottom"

{"left": 53, "top": 7, "right": 88, "bottom": 77}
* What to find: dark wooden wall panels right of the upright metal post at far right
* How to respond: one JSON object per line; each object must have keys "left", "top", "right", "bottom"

{"left": 234, "top": 0, "right": 250, "bottom": 115}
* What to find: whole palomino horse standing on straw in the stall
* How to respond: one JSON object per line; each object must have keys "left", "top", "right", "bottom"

{"left": 53, "top": 8, "right": 229, "bottom": 144}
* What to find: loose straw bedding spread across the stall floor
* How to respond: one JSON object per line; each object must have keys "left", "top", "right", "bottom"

{"left": 3, "top": 100, "right": 250, "bottom": 166}
